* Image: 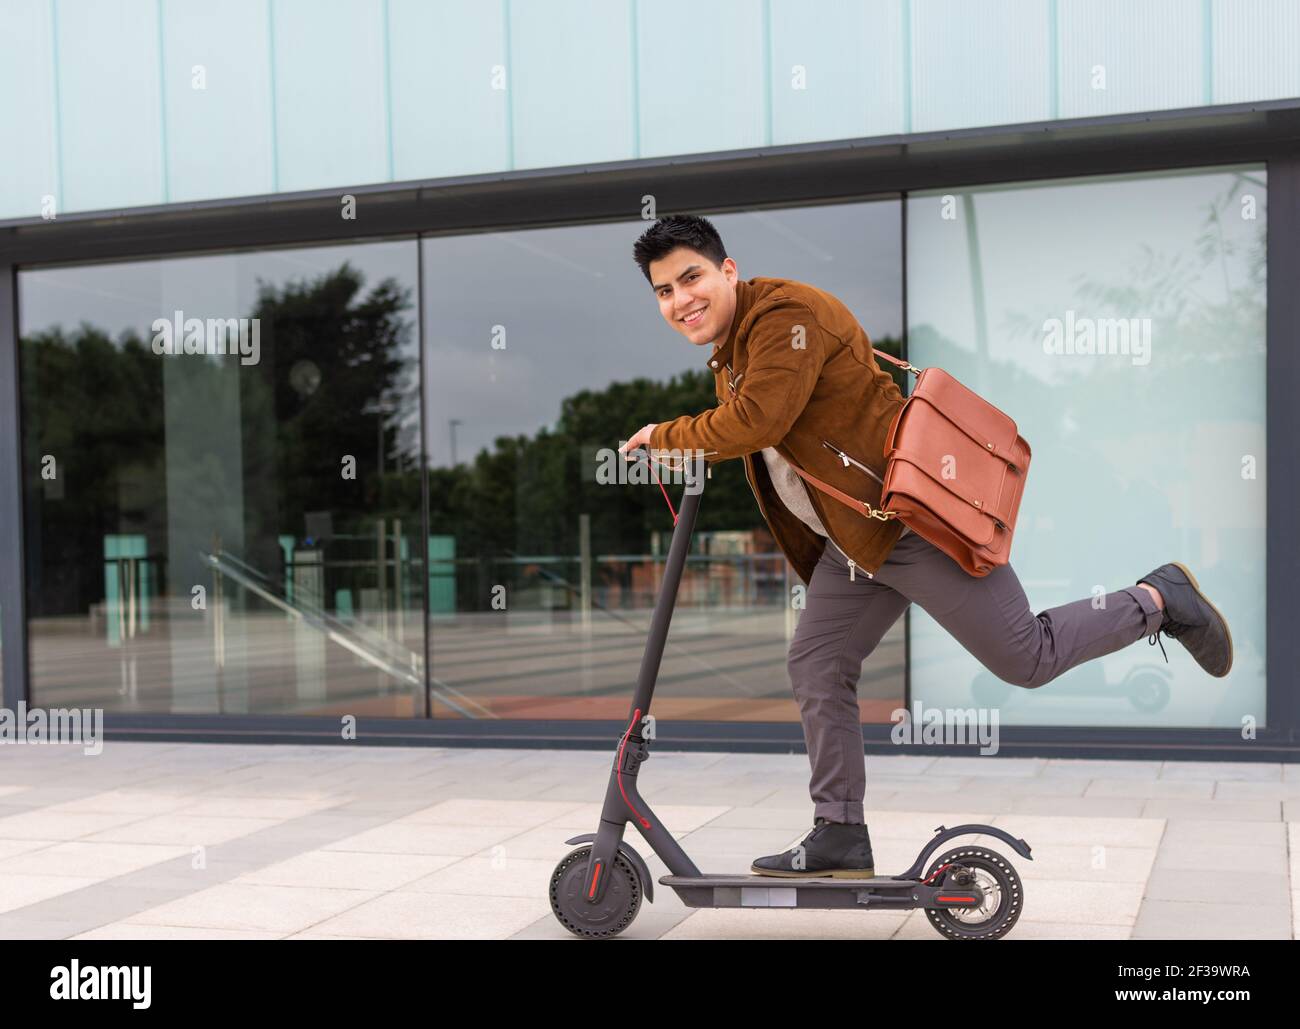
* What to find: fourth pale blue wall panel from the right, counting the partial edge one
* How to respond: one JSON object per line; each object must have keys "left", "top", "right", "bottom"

{"left": 771, "top": 0, "right": 904, "bottom": 143}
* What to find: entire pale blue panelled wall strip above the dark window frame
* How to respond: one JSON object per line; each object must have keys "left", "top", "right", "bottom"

{"left": 0, "top": 0, "right": 1300, "bottom": 218}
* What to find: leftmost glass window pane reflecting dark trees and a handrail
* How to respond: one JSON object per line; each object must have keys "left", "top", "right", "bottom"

{"left": 18, "top": 240, "right": 425, "bottom": 717}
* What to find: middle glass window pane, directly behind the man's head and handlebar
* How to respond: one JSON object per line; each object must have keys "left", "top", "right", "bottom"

{"left": 423, "top": 201, "right": 904, "bottom": 722}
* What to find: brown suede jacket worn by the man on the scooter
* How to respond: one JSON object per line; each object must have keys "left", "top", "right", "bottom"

{"left": 650, "top": 278, "right": 904, "bottom": 583}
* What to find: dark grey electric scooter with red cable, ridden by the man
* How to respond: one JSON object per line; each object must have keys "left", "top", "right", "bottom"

{"left": 550, "top": 457, "right": 1032, "bottom": 939}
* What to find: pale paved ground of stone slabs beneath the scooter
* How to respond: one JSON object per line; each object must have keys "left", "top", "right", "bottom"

{"left": 0, "top": 742, "right": 1300, "bottom": 939}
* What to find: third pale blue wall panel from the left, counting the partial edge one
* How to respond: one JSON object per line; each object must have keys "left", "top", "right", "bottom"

{"left": 163, "top": 0, "right": 276, "bottom": 200}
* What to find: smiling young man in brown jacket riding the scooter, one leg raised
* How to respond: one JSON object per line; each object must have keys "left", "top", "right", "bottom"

{"left": 620, "top": 216, "right": 1232, "bottom": 877}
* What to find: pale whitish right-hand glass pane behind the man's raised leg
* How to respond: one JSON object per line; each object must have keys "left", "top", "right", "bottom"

{"left": 907, "top": 168, "right": 1266, "bottom": 728}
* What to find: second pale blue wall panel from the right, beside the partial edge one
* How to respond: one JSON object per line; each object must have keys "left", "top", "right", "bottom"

{"left": 1057, "top": 0, "right": 1206, "bottom": 118}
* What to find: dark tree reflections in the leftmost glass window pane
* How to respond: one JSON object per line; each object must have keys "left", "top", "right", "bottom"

{"left": 21, "top": 264, "right": 420, "bottom": 615}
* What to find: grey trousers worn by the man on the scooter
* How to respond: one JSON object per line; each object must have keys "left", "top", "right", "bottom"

{"left": 787, "top": 533, "right": 1164, "bottom": 822}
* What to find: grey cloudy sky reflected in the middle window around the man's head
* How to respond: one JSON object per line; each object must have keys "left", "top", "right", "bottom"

{"left": 424, "top": 201, "right": 902, "bottom": 466}
